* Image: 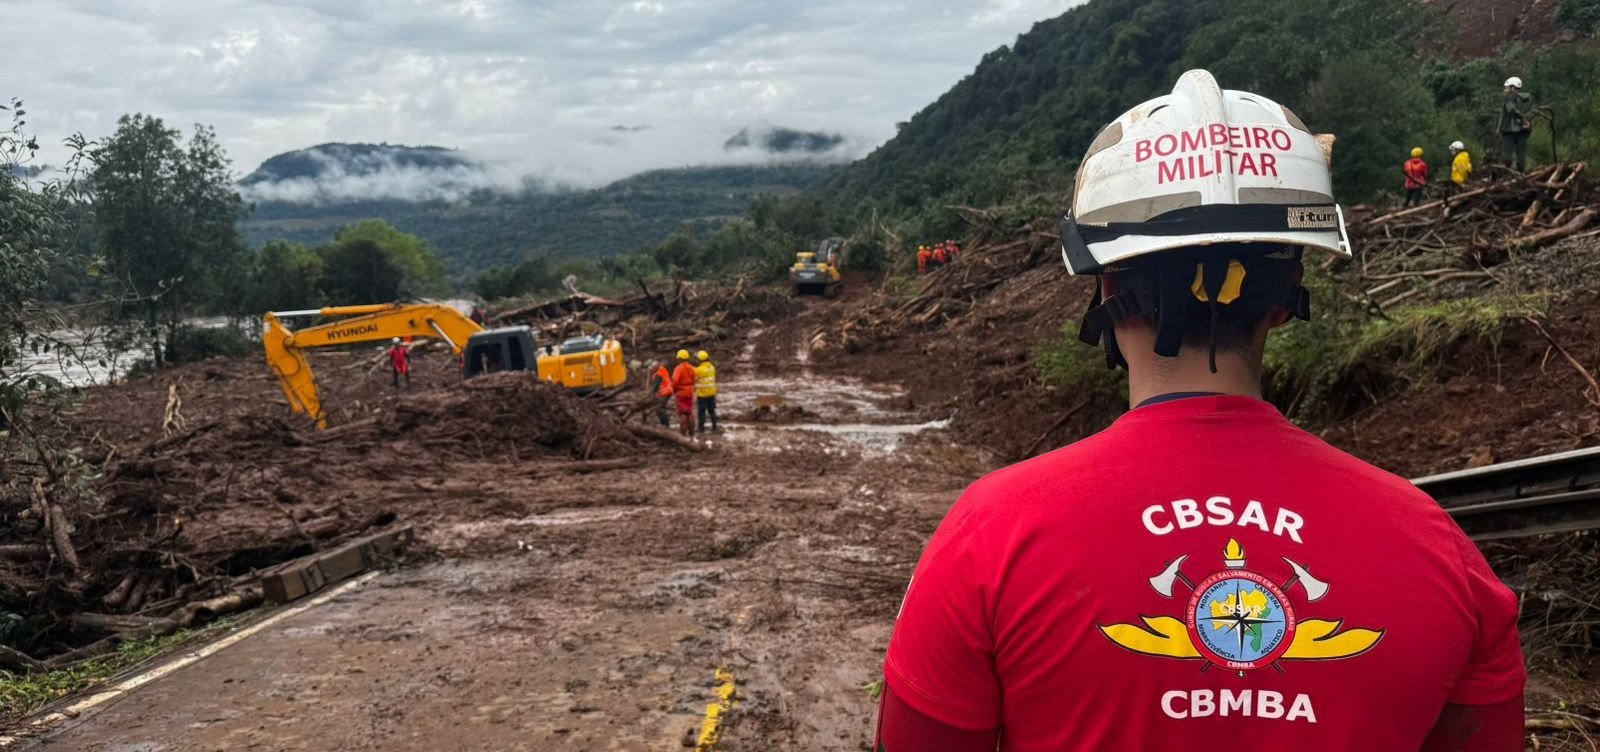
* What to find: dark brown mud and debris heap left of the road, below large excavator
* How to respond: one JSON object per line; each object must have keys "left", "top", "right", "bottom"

{"left": 0, "top": 362, "right": 682, "bottom": 670}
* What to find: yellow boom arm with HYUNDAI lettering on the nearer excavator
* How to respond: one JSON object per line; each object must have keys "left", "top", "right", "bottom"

{"left": 261, "top": 302, "right": 483, "bottom": 430}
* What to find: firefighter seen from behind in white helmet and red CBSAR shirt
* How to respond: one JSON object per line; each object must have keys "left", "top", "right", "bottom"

{"left": 878, "top": 70, "right": 1526, "bottom": 752}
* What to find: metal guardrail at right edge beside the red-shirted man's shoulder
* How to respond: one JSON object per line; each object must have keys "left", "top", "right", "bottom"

{"left": 1411, "top": 448, "right": 1600, "bottom": 541}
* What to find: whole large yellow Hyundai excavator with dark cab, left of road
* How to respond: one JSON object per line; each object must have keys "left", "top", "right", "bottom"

{"left": 261, "top": 302, "right": 627, "bottom": 430}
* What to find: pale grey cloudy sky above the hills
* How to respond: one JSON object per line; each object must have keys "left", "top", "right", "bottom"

{"left": 0, "top": 0, "right": 1082, "bottom": 182}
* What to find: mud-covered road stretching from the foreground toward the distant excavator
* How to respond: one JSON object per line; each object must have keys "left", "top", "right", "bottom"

{"left": 18, "top": 318, "right": 987, "bottom": 752}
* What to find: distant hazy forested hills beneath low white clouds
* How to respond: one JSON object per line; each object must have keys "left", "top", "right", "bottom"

{"left": 240, "top": 163, "right": 834, "bottom": 280}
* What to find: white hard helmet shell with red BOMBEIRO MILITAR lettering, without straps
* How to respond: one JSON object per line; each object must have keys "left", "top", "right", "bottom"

{"left": 1061, "top": 70, "right": 1350, "bottom": 274}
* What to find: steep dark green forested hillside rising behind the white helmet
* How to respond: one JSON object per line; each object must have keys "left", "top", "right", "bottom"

{"left": 814, "top": 0, "right": 1580, "bottom": 219}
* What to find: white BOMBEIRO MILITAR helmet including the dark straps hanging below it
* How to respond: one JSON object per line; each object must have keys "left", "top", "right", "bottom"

{"left": 1061, "top": 70, "right": 1350, "bottom": 371}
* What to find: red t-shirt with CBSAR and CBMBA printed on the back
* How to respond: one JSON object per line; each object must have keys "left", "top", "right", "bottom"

{"left": 885, "top": 397, "right": 1526, "bottom": 752}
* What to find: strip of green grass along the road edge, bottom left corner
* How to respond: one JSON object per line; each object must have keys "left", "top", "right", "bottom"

{"left": 0, "top": 611, "right": 251, "bottom": 728}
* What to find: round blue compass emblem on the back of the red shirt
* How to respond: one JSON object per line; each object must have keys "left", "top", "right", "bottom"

{"left": 1186, "top": 570, "right": 1294, "bottom": 670}
